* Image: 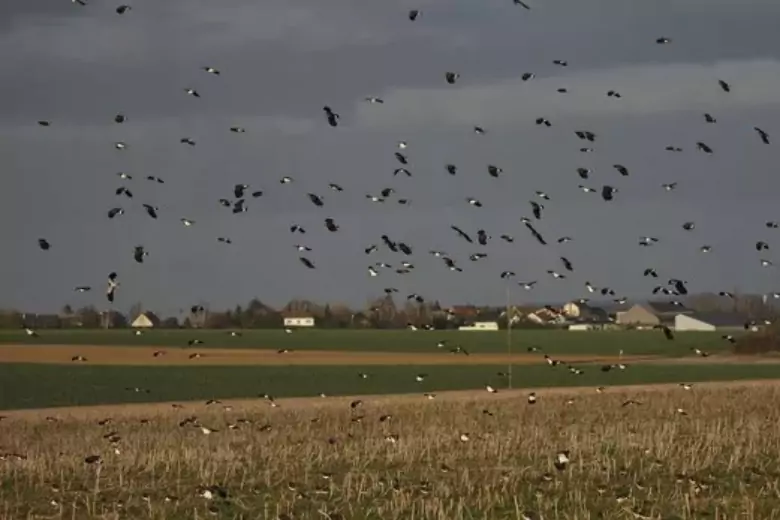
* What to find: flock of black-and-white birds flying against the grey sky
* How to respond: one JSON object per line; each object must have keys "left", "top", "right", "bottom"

{"left": 27, "top": 0, "right": 780, "bottom": 330}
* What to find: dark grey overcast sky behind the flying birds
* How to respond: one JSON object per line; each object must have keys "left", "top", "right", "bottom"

{"left": 0, "top": 0, "right": 780, "bottom": 314}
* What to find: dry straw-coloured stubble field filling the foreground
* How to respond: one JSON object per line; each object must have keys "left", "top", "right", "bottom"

{"left": 0, "top": 383, "right": 780, "bottom": 520}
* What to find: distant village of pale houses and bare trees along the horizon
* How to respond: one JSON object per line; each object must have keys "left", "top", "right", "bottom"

{"left": 0, "top": 294, "right": 780, "bottom": 331}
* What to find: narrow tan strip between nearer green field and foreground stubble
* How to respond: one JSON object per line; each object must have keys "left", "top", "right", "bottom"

{"left": 2, "top": 379, "right": 780, "bottom": 421}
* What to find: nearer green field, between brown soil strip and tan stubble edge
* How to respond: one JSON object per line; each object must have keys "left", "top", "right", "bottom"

{"left": 0, "top": 364, "right": 780, "bottom": 410}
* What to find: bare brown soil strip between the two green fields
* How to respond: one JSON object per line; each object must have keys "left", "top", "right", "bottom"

{"left": 0, "top": 345, "right": 658, "bottom": 366}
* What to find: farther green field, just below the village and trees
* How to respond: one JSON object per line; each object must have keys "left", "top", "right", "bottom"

{"left": 0, "top": 329, "right": 729, "bottom": 357}
